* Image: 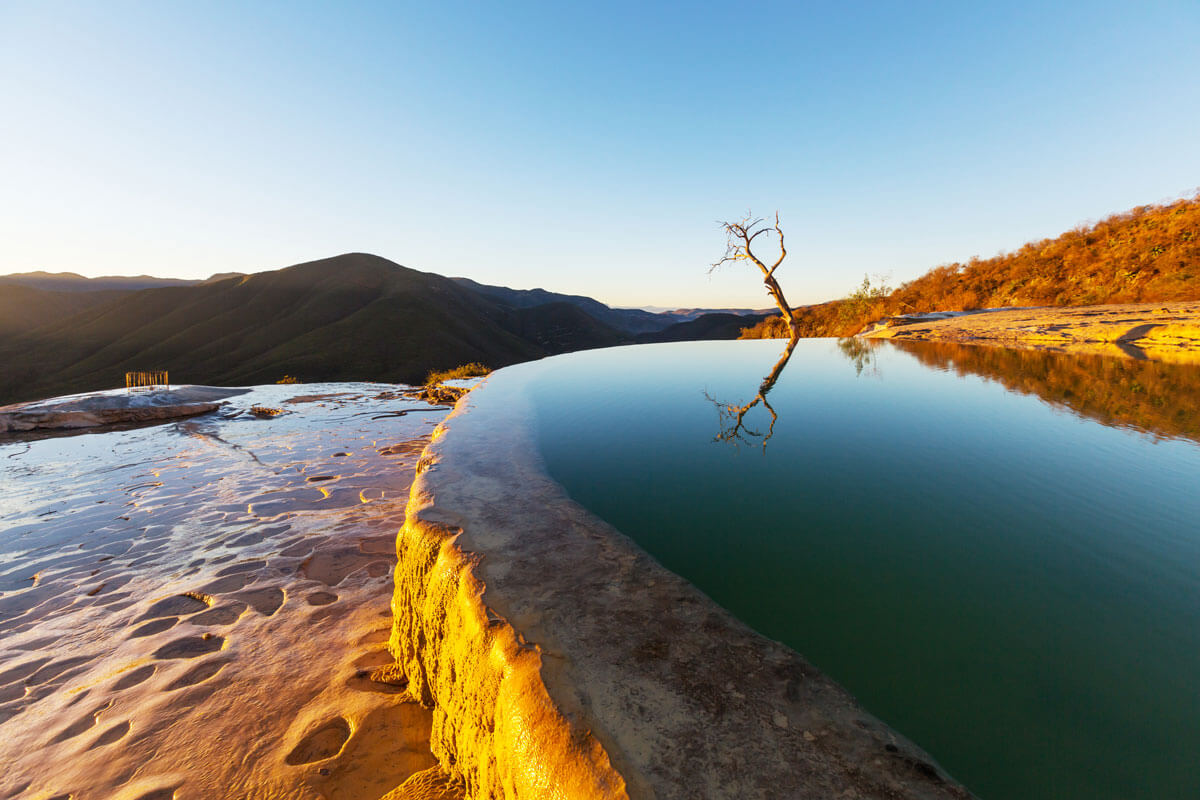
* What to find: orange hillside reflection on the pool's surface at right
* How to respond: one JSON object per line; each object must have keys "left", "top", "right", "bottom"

{"left": 892, "top": 341, "right": 1200, "bottom": 441}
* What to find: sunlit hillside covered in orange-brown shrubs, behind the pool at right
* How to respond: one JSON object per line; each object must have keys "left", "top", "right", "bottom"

{"left": 746, "top": 194, "right": 1200, "bottom": 338}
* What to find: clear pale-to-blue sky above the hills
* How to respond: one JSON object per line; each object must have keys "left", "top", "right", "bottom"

{"left": 0, "top": 0, "right": 1200, "bottom": 307}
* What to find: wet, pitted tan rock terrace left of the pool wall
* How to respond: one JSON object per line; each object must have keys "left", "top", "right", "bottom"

{"left": 0, "top": 384, "right": 461, "bottom": 800}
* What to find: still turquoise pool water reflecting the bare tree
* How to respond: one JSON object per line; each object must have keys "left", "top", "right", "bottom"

{"left": 526, "top": 339, "right": 1200, "bottom": 799}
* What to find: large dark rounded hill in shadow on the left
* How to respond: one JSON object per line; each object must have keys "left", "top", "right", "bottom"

{"left": 0, "top": 253, "right": 629, "bottom": 403}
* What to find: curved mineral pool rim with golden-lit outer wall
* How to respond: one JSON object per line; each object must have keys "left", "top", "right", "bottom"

{"left": 390, "top": 362, "right": 971, "bottom": 798}
